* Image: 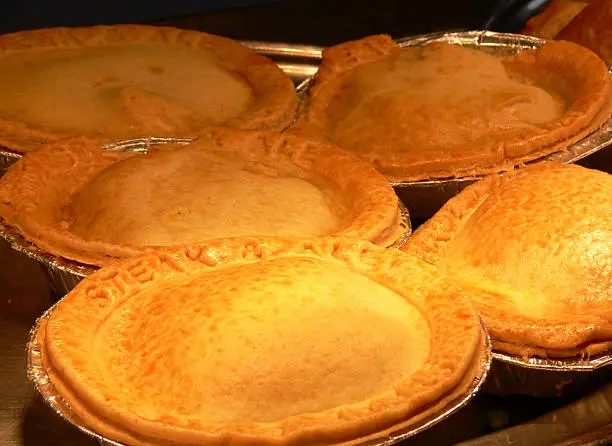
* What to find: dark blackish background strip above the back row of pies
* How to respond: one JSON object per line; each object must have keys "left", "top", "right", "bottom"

{"left": 0, "top": 0, "right": 547, "bottom": 45}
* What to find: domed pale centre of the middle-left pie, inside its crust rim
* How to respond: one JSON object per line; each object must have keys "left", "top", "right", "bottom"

{"left": 65, "top": 148, "right": 345, "bottom": 246}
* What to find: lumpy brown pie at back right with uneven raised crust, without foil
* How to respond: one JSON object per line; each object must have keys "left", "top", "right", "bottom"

{"left": 295, "top": 35, "right": 612, "bottom": 181}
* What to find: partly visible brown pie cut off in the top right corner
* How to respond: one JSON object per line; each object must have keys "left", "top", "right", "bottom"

{"left": 521, "top": 0, "right": 612, "bottom": 64}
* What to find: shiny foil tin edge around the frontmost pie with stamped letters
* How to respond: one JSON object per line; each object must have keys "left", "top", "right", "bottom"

{"left": 26, "top": 300, "right": 491, "bottom": 446}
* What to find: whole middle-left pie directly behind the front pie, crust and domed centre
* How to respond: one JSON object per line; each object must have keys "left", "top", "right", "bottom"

{"left": 0, "top": 127, "right": 404, "bottom": 266}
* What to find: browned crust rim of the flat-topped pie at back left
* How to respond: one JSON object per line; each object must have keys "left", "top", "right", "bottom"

{"left": 0, "top": 25, "right": 297, "bottom": 152}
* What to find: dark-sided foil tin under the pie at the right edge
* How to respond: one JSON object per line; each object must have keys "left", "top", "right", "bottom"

{"left": 483, "top": 351, "right": 612, "bottom": 397}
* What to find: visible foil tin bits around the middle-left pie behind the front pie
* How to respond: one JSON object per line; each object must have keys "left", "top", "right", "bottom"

{"left": 0, "top": 137, "right": 412, "bottom": 297}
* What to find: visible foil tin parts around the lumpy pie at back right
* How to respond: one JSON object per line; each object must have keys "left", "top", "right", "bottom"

{"left": 298, "top": 31, "right": 612, "bottom": 219}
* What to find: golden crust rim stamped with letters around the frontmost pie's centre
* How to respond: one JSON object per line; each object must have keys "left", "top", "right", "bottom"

{"left": 41, "top": 238, "right": 486, "bottom": 445}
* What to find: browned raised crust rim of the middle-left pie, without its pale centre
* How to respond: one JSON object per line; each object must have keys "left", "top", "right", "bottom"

{"left": 0, "top": 128, "right": 402, "bottom": 266}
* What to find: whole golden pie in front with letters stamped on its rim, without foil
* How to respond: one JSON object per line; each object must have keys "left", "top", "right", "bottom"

{"left": 40, "top": 238, "right": 487, "bottom": 446}
